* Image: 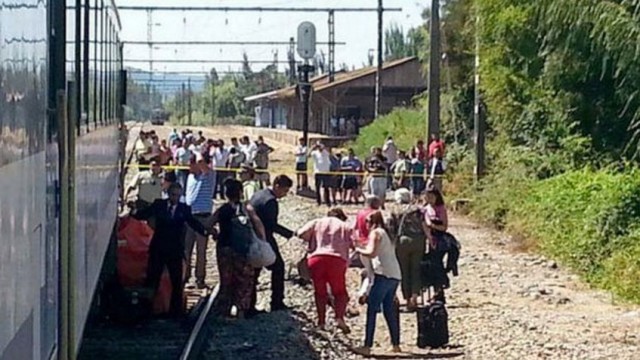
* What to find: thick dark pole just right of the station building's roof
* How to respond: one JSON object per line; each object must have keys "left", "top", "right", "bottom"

{"left": 427, "top": 0, "right": 441, "bottom": 141}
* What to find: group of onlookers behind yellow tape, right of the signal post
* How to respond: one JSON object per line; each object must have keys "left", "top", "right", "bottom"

{"left": 302, "top": 135, "right": 447, "bottom": 206}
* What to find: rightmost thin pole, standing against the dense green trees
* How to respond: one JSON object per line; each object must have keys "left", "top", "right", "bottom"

{"left": 473, "top": 1, "right": 485, "bottom": 182}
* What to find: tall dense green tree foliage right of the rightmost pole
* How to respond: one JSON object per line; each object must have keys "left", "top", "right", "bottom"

{"left": 478, "top": 0, "right": 640, "bottom": 158}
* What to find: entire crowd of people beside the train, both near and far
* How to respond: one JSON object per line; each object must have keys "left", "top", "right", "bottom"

{"left": 127, "top": 130, "right": 457, "bottom": 354}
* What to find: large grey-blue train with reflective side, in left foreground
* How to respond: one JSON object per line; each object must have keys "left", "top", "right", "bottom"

{"left": 0, "top": 0, "right": 126, "bottom": 360}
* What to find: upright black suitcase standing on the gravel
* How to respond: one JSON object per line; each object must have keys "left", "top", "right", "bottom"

{"left": 416, "top": 290, "right": 449, "bottom": 349}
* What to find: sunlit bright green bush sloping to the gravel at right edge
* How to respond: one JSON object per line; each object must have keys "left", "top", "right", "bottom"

{"left": 502, "top": 169, "right": 640, "bottom": 301}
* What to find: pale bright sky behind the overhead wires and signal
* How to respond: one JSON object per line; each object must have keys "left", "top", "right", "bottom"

{"left": 116, "top": 0, "right": 428, "bottom": 78}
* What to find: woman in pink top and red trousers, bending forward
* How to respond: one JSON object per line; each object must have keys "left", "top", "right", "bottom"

{"left": 297, "top": 208, "right": 354, "bottom": 334}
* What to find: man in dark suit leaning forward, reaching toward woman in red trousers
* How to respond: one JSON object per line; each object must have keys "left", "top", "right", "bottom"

{"left": 249, "top": 175, "right": 294, "bottom": 315}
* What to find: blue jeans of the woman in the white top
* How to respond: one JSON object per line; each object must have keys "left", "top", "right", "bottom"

{"left": 364, "top": 275, "right": 400, "bottom": 347}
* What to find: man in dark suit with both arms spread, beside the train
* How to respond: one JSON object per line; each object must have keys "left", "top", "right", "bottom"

{"left": 131, "top": 183, "right": 209, "bottom": 316}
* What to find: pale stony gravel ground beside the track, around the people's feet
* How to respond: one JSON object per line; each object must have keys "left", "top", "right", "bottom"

{"left": 146, "top": 124, "right": 640, "bottom": 360}
